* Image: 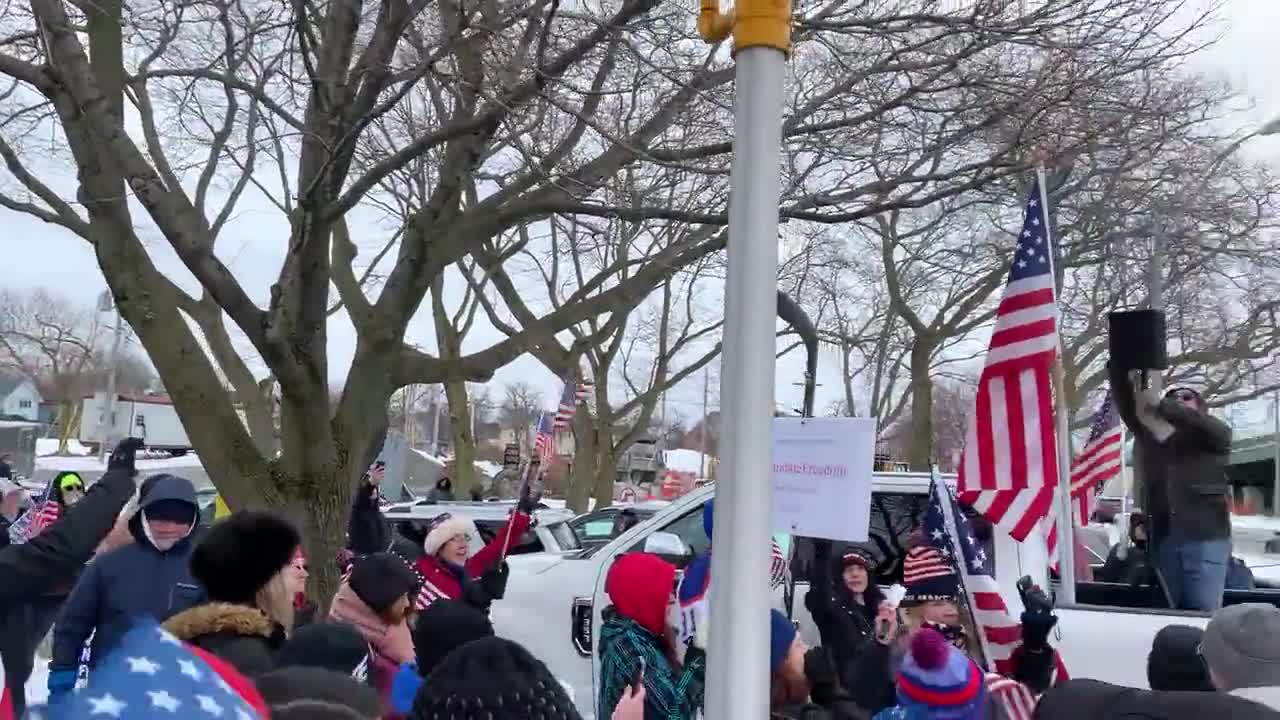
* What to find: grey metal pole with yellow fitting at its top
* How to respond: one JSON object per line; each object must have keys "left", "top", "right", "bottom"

{"left": 698, "top": 0, "right": 791, "bottom": 707}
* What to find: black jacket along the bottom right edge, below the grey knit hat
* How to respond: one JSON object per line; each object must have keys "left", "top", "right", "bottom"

{"left": 1033, "top": 680, "right": 1280, "bottom": 720}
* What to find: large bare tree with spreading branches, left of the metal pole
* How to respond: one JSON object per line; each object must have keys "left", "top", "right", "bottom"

{"left": 0, "top": 0, "right": 1223, "bottom": 589}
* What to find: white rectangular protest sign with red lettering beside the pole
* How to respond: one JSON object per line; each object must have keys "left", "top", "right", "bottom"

{"left": 771, "top": 418, "right": 876, "bottom": 542}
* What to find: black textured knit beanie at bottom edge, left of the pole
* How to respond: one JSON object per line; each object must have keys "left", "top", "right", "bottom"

{"left": 412, "top": 638, "right": 581, "bottom": 720}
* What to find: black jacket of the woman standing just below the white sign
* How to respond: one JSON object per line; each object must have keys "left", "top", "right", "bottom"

{"left": 804, "top": 543, "right": 881, "bottom": 687}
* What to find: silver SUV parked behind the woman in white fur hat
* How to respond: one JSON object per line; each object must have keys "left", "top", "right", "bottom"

{"left": 383, "top": 500, "right": 581, "bottom": 555}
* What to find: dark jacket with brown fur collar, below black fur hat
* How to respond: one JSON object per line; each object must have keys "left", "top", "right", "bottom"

{"left": 164, "top": 602, "right": 285, "bottom": 678}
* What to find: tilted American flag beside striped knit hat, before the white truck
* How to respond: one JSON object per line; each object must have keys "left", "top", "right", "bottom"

{"left": 916, "top": 477, "right": 1066, "bottom": 720}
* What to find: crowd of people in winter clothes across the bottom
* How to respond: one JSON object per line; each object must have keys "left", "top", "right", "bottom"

{"left": 0, "top": 397, "right": 1280, "bottom": 720}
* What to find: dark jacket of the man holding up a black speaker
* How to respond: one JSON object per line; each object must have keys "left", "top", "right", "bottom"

{"left": 1111, "top": 369, "right": 1231, "bottom": 544}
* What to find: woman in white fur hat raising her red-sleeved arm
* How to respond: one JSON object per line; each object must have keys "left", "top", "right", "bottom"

{"left": 415, "top": 486, "right": 538, "bottom": 612}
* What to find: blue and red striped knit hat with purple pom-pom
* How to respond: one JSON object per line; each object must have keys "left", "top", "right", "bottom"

{"left": 897, "top": 628, "right": 987, "bottom": 720}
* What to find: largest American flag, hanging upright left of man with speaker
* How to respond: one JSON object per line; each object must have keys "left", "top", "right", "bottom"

{"left": 959, "top": 176, "right": 1059, "bottom": 541}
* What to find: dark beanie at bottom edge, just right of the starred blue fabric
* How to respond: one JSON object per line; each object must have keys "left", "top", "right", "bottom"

{"left": 255, "top": 667, "right": 383, "bottom": 720}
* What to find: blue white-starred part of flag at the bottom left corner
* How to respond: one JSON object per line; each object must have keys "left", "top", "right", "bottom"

{"left": 47, "top": 620, "right": 261, "bottom": 720}
